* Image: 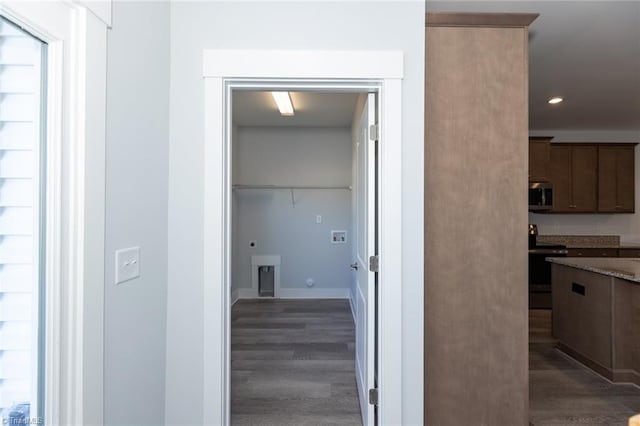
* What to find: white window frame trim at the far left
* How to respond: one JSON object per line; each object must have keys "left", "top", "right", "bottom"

{"left": 0, "top": 0, "right": 107, "bottom": 425}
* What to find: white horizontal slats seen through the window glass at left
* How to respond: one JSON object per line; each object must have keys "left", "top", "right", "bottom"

{"left": 0, "top": 19, "right": 43, "bottom": 418}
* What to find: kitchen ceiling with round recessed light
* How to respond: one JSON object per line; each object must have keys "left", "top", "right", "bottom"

{"left": 426, "top": 0, "right": 640, "bottom": 131}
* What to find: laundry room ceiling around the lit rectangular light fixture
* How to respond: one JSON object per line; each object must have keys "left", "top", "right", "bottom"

{"left": 232, "top": 90, "right": 358, "bottom": 127}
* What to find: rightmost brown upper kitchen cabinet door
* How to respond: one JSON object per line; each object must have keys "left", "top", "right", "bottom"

{"left": 598, "top": 145, "right": 635, "bottom": 213}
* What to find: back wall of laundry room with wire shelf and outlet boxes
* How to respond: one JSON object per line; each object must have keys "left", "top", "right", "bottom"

{"left": 232, "top": 127, "right": 351, "bottom": 297}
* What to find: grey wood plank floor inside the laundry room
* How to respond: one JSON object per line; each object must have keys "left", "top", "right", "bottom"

{"left": 231, "top": 299, "right": 362, "bottom": 426}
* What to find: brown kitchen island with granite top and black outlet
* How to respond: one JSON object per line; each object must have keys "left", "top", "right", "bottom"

{"left": 547, "top": 258, "right": 640, "bottom": 385}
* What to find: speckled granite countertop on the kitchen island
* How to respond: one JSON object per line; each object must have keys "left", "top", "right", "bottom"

{"left": 547, "top": 257, "right": 640, "bottom": 284}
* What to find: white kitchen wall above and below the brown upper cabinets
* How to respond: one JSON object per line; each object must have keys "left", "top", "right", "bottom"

{"left": 529, "top": 130, "right": 640, "bottom": 242}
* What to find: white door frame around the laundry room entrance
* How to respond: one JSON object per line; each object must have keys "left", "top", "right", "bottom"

{"left": 203, "top": 49, "right": 404, "bottom": 425}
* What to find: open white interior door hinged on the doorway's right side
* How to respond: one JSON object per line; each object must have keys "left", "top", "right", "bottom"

{"left": 353, "top": 93, "right": 377, "bottom": 426}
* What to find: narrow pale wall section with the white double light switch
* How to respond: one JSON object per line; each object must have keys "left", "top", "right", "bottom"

{"left": 104, "top": 2, "right": 169, "bottom": 425}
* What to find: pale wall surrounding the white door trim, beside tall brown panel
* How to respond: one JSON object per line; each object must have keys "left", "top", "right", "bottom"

{"left": 166, "top": 0, "right": 425, "bottom": 426}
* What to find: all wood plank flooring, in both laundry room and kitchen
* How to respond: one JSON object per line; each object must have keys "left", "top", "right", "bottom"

{"left": 231, "top": 299, "right": 640, "bottom": 426}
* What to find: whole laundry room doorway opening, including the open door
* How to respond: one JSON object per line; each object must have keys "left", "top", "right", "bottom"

{"left": 229, "top": 87, "right": 377, "bottom": 425}
